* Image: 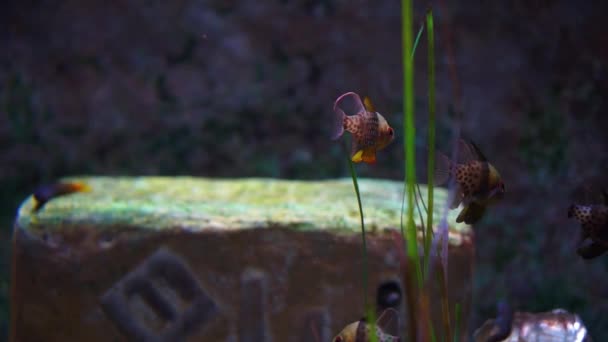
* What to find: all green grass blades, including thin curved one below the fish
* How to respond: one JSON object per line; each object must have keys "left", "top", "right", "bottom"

{"left": 347, "top": 0, "right": 460, "bottom": 342}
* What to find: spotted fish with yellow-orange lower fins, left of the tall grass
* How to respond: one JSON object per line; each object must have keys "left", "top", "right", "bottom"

{"left": 332, "top": 92, "right": 395, "bottom": 164}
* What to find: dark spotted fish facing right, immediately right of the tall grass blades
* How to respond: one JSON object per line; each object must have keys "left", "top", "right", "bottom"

{"left": 435, "top": 140, "right": 505, "bottom": 224}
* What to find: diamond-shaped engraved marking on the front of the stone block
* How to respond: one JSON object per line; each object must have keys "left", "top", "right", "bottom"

{"left": 101, "top": 248, "right": 218, "bottom": 341}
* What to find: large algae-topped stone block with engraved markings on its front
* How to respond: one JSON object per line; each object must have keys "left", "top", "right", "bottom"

{"left": 11, "top": 177, "right": 473, "bottom": 341}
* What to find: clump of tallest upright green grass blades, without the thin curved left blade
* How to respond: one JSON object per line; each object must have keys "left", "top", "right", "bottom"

{"left": 401, "top": 0, "right": 460, "bottom": 341}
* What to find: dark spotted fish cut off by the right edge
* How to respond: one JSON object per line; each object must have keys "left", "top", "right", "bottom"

{"left": 568, "top": 191, "right": 608, "bottom": 259}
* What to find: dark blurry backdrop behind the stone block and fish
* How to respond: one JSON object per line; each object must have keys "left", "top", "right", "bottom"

{"left": 0, "top": 0, "right": 608, "bottom": 341}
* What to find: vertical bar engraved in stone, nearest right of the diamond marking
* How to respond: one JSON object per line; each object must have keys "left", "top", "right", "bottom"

{"left": 238, "top": 269, "right": 272, "bottom": 342}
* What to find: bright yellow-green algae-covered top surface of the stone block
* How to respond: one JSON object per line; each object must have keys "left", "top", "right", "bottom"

{"left": 18, "top": 177, "right": 470, "bottom": 242}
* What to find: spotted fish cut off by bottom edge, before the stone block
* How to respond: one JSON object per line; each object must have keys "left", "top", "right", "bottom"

{"left": 332, "top": 308, "right": 401, "bottom": 342}
